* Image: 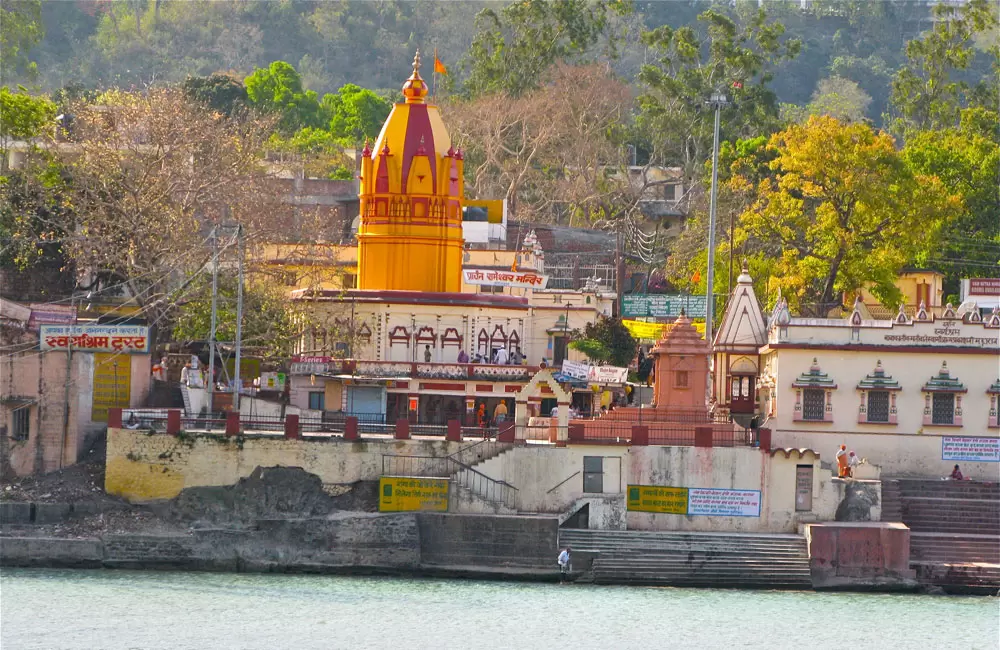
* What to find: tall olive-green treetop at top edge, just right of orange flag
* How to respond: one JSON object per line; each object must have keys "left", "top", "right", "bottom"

{"left": 463, "top": 0, "right": 631, "bottom": 97}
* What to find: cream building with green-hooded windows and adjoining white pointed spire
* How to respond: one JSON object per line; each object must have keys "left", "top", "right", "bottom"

{"left": 713, "top": 282, "right": 1000, "bottom": 480}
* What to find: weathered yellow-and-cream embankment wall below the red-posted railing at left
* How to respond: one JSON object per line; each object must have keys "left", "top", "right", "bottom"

{"left": 104, "top": 429, "right": 467, "bottom": 502}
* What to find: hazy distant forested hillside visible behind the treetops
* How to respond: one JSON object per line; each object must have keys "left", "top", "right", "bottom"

{"left": 3, "top": 0, "right": 987, "bottom": 123}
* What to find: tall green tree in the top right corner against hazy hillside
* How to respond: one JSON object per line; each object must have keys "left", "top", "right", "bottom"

{"left": 892, "top": 0, "right": 998, "bottom": 132}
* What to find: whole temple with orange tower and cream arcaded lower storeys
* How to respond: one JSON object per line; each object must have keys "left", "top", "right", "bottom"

{"left": 276, "top": 54, "right": 615, "bottom": 424}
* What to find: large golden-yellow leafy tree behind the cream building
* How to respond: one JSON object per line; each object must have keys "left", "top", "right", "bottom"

{"left": 736, "top": 117, "right": 962, "bottom": 316}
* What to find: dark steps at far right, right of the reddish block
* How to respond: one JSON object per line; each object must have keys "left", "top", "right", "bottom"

{"left": 882, "top": 478, "right": 1000, "bottom": 593}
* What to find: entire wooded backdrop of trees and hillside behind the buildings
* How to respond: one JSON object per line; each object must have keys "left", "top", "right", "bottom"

{"left": 0, "top": 0, "right": 1000, "bottom": 314}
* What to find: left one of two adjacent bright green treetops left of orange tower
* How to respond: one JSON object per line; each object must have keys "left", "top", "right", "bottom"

{"left": 244, "top": 61, "right": 327, "bottom": 133}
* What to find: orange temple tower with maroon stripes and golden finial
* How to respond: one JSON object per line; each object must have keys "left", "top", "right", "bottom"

{"left": 358, "top": 51, "right": 465, "bottom": 292}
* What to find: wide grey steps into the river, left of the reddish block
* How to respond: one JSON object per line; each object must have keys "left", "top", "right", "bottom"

{"left": 559, "top": 528, "right": 812, "bottom": 589}
